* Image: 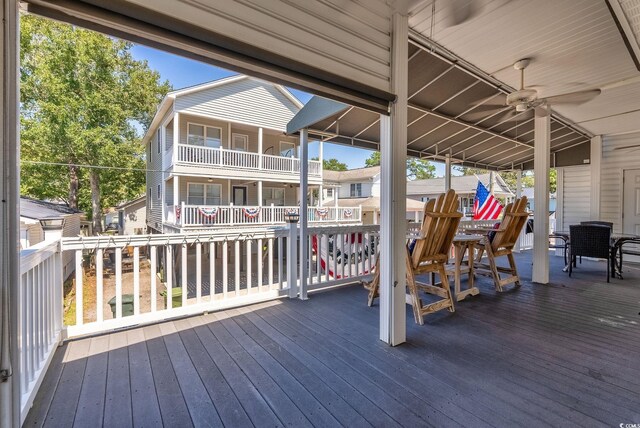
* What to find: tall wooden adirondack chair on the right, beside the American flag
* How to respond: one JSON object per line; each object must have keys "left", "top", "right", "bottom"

{"left": 474, "top": 196, "right": 529, "bottom": 291}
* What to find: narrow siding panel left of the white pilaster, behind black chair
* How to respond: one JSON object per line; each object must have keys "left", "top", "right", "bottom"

{"left": 556, "top": 165, "right": 593, "bottom": 230}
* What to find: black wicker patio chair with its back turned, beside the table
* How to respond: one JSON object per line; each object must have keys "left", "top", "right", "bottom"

{"left": 569, "top": 224, "right": 611, "bottom": 282}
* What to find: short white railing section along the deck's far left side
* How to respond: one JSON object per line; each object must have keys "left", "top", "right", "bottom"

{"left": 16, "top": 241, "right": 63, "bottom": 422}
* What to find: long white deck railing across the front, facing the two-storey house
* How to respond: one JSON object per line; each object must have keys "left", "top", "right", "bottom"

{"left": 62, "top": 226, "right": 378, "bottom": 337}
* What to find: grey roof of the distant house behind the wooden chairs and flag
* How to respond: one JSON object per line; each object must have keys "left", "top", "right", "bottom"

{"left": 407, "top": 174, "right": 513, "bottom": 196}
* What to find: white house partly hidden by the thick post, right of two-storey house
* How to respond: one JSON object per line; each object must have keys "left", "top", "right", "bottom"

{"left": 322, "top": 166, "right": 424, "bottom": 224}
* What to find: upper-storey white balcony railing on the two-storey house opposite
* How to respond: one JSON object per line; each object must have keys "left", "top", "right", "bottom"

{"left": 174, "top": 144, "right": 322, "bottom": 183}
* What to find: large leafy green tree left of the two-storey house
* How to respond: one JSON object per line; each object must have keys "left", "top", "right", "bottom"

{"left": 20, "top": 15, "right": 171, "bottom": 232}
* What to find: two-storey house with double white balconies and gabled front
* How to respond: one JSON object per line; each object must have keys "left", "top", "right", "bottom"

{"left": 144, "top": 76, "right": 348, "bottom": 233}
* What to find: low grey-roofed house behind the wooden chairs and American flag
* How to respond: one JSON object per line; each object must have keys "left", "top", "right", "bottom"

{"left": 407, "top": 173, "right": 515, "bottom": 217}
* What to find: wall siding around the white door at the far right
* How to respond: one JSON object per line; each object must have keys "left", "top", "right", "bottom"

{"left": 600, "top": 134, "right": 640, "bottom": 232}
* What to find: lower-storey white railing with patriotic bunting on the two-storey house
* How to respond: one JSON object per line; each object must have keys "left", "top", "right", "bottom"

{"left": 164, "top": 204, "right": 362, "bottom": 227}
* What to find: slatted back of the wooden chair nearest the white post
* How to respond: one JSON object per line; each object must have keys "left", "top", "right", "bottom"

{"left": 411, "top": 190, "right": 462, "bottom": 268}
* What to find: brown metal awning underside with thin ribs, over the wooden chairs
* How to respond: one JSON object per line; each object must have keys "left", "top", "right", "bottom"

{"left": 290, "top": 40, "right": 591, "bottom": 170}
